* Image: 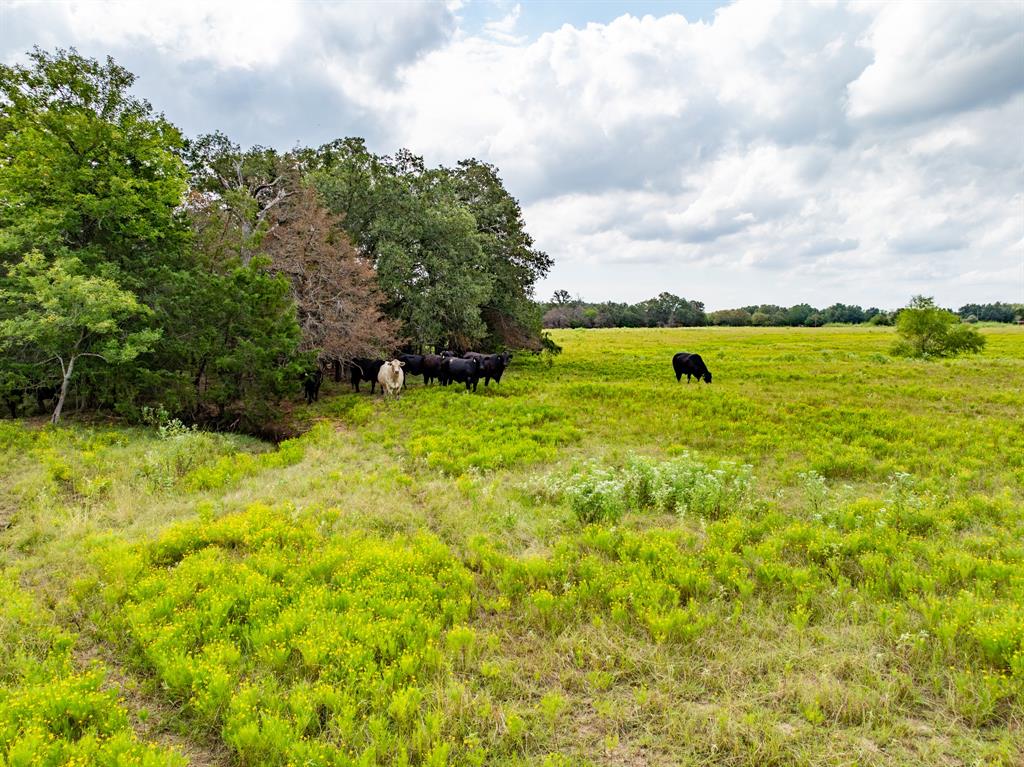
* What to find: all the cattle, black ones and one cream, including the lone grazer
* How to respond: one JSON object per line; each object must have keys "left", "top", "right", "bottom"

{"left": 302, "top": 351, "right": 711, "bottom": 403}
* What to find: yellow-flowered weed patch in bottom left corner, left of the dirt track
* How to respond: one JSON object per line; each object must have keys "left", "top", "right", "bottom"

{"left": 0, "top": 573, "right": 185, "bottom": 767}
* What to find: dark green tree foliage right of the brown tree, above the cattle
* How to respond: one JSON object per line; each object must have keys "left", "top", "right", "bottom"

{"left": 310, "top": 138, "right": 551, "bottom": 347}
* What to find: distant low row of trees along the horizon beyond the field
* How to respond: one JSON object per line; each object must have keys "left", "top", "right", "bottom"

{"left": 541, "top": 290, "right": 1024, "bottom": 328}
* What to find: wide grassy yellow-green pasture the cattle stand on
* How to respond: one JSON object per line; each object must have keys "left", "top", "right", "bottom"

{"left": 0, "top": 327, "right": 1024, "bottom": 767}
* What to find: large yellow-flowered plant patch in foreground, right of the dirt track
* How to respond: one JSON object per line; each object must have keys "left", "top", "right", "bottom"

{"left": 90, "top": 507, "right": 475, "bottom": 765}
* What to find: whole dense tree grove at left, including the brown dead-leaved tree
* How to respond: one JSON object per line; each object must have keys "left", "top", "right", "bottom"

{"left": 0, "top": 48, "right": 551, "bottom": 430}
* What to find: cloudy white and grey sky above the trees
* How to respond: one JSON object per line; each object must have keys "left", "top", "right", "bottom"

{"left": 0, "top": 0, "right": 1024, "bottom": 309}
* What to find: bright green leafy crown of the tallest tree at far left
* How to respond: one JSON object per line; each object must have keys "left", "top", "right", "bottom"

{"left": 0, "top": 48, "right": 186, "bottom": 286}
